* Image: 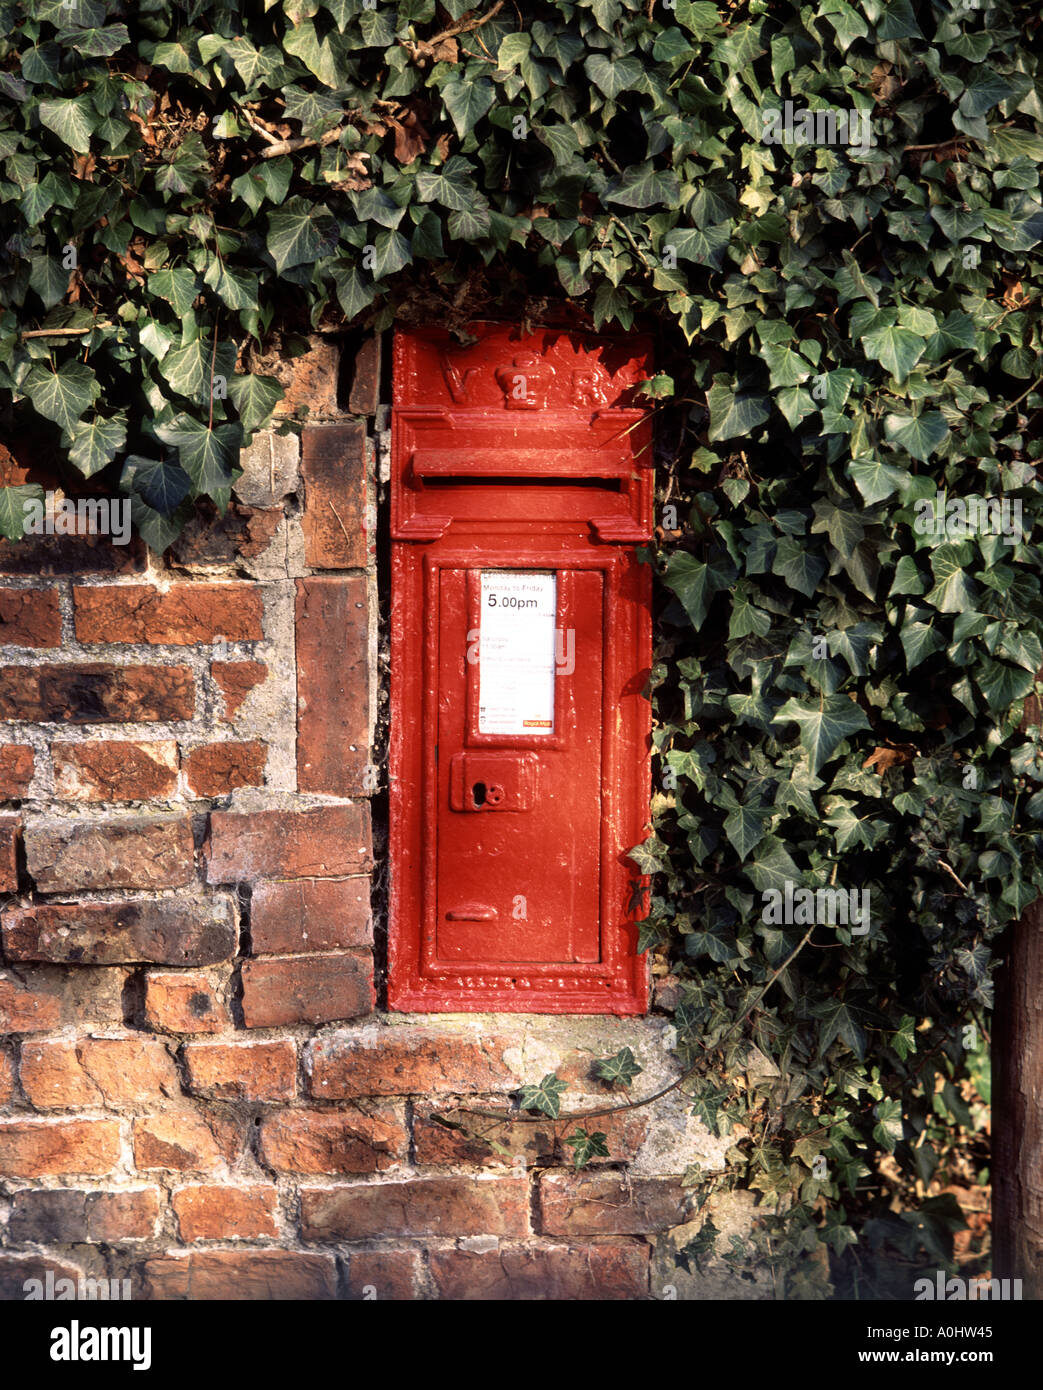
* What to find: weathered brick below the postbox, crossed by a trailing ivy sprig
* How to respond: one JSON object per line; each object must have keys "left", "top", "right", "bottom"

{"left": 413, "top": 1101, "right": 651, "bottom": 1168}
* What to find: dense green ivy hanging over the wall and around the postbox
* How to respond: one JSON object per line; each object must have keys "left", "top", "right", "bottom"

{"left": 0, "top": 0, "right": 1043, "bottom": 1293}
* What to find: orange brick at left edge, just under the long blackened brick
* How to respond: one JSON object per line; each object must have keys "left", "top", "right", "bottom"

{"left": 0, "top": 966, "right": 127, "bottom": 1033}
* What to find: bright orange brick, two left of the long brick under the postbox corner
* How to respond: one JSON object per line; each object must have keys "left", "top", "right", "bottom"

{"left": 19, "top": 1037, "right": 181, "bottom": 1109}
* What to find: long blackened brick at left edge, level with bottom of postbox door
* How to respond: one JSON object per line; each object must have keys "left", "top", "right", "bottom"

{"left": 0, "top": 895, "right": 235, "bottom": 965}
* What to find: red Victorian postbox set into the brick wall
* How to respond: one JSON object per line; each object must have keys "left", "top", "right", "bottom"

{"left": 388, "top": 324, "right": 652, "bottom": 1013}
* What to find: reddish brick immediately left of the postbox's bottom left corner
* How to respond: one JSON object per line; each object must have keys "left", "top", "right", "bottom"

{"left": 242, "top": 954, "right": 375, "bottom": 1029}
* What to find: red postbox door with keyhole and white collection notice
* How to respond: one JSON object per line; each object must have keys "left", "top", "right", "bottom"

{"left": 430, "top": 566, "right": 605, "bottom": 973}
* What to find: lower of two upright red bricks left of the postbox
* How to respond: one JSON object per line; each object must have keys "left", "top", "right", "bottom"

{"left": 296, "top": 577, "right": 370, "bottom": 796}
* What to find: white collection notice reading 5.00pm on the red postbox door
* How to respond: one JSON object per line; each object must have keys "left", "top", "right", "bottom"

{"left": 478, "top": 570, "right": 558, "bottom": 734}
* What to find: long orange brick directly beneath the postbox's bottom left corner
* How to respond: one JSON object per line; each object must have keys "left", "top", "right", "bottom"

{"left": 306, "top": 1027, "right": 519, "bottom": 1101}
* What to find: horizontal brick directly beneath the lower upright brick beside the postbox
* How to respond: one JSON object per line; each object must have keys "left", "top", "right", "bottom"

{"left": 207, "top": 806, "right": 370, "bottom": 883}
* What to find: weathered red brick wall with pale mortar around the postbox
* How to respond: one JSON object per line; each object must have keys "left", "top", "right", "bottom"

{"left": 0, "top": 339, "right": 734, "bottom": 1300}
